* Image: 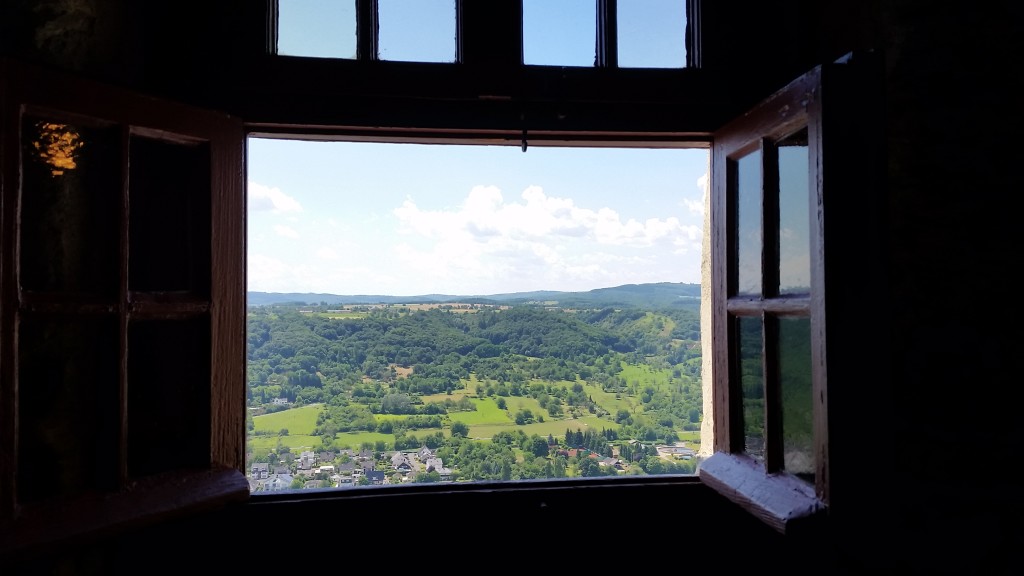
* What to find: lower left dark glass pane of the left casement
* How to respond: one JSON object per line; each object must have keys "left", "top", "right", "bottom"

{"left": 17, "top": 315, "right": 121, "bottom": 502}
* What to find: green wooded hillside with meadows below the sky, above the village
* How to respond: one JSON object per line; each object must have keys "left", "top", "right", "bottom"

{"left": 248, "top": 285, "right": 702, "bottom": 480}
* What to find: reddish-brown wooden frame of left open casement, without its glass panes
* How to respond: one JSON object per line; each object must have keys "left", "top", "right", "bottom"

{"left": 0, "top": 59, "right": 249, "bottom": 552}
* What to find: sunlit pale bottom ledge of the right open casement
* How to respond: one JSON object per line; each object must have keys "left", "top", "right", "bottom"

{"left": 698, "top": 452, "right": 827, "bottom": 534}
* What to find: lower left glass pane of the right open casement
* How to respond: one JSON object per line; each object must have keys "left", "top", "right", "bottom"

{"left": 736, "top": 318, "right": 765, "bottom": 460}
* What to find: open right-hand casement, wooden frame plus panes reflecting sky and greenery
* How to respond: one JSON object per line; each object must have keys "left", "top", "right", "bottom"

{"left": 700, "top": 54, "right": 881, "bottom": 533}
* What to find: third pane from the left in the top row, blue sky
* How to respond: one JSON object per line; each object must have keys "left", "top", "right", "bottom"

{"left": 522, "top": 0, "right": 597, "bottom": 66}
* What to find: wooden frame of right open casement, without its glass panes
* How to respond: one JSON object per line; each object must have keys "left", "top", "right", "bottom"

{"left": 699, "top": 53, "right": 884, "bottom": 534}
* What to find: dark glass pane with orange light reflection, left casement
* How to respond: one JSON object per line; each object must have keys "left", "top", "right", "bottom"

{"left": 19, "top": 117, "right": 121, "bottom": 297}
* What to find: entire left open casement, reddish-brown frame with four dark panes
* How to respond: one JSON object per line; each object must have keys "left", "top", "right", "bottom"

{"left": 0, "top": 58, "right": 248, "bottom": 549}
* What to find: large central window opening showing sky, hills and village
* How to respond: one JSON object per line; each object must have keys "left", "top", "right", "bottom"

{"left": 247, "top": 137, "right": 710, "bottom": 492}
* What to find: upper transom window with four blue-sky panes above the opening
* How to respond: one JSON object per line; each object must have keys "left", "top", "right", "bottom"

{"left": 270, "top": 0, "right": 697, "bottom": 68}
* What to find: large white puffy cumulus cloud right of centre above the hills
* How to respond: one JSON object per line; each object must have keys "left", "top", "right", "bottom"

{"left": 385, "top": 186, "right": 701, "bottom": 293}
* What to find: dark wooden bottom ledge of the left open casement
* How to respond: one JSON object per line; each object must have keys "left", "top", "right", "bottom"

{"left": 0, "top": 469, "right": 249, "bottom": 557}
